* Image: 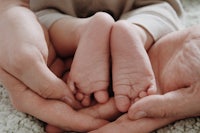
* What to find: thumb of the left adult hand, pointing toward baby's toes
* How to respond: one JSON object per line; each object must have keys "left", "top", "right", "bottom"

{"left": 17, "top": 59, "right": 80, "bottom": 108}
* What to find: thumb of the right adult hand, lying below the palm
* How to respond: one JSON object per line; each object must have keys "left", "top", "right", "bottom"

{"left": 128, "top": 88, "right": 200, "bottom": 120}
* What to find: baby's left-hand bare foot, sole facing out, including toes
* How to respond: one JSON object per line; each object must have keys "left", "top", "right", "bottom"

{"left": 68, "top": 13, "right": 113, "bottom": 106}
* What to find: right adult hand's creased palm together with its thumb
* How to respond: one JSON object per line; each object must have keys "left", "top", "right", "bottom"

{"left": 128, "top": 26, "right": 200, "bottom": 119}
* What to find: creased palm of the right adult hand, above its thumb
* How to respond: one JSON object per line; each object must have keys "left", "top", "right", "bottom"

{"left": 149, "top": 26, "right": 200, "bottom": 93}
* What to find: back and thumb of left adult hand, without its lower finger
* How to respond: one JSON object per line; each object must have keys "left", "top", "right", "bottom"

{"left": 0, "top": 2, "right": 75, "bottom": 105}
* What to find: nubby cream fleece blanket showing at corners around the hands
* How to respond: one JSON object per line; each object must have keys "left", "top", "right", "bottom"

{"left": 0, "top": 0, "right": 200, "bottom": 133}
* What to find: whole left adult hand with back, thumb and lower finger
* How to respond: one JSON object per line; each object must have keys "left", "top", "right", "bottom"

{"left": 0, "top": 0, "right": 107, "bottom": 131}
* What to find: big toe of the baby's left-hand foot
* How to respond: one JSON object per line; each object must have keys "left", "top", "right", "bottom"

{"left": 94, "top": 91, "right": 109, "bottom": 103}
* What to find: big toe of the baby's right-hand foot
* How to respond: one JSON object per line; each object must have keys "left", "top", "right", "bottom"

{"left": 115, "top": 95, "right": 131, "bottom": 112}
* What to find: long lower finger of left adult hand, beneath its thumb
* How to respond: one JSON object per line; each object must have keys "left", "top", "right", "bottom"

{"left": 1, "top": 71, "right": 107, "bottom": 131}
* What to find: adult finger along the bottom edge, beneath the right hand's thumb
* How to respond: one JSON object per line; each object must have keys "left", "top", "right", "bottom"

{"left": 89, "top": 114, "right": 174, "bottom": 133}
